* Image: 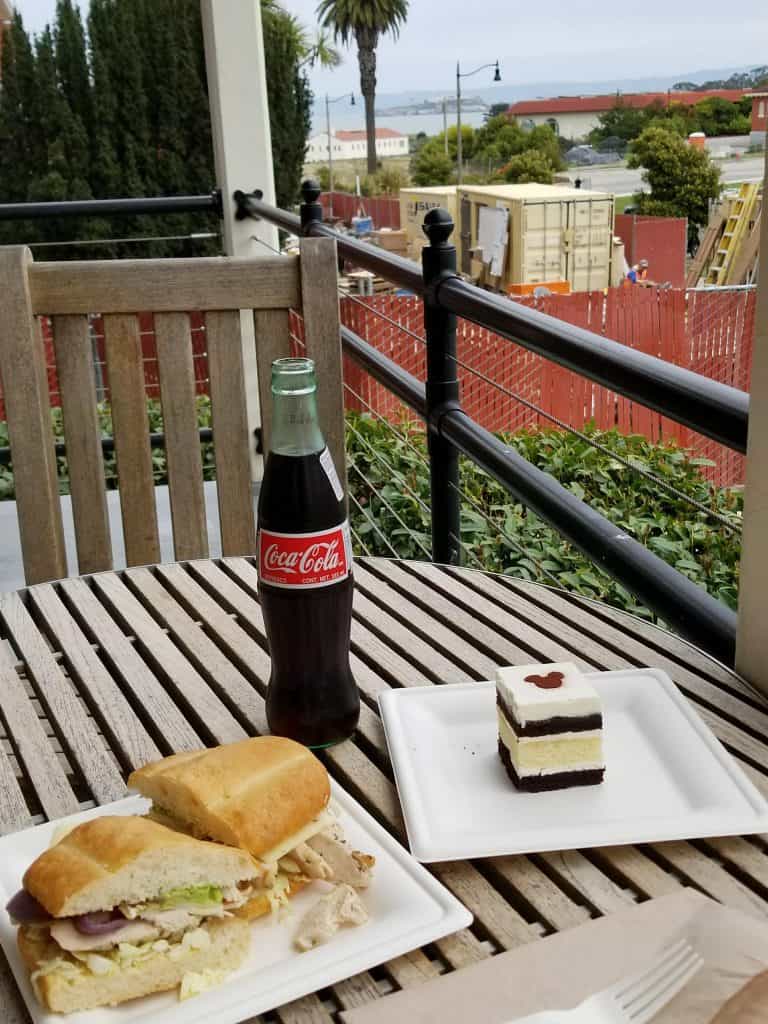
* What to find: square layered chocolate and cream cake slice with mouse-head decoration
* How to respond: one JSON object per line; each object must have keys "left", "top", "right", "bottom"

{"left": 496, "top": 662, "right": 605, "bottom": 793}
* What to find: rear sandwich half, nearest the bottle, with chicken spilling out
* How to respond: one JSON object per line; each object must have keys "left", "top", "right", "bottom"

{"left": 128, "top": 736, "right": 374, "bottom": 924}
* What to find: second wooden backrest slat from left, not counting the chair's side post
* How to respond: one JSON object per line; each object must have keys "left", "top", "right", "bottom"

{"left": 103, "top": 313, "right": 160, "bottom": 565}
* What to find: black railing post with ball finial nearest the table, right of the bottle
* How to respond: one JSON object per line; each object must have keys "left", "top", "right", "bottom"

{"left": 421, "top": 209, "right": 461, "bottom": 565}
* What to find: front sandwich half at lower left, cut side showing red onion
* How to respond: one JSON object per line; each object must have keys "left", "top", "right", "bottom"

{"left": 7, "top": 816, "right": 263, "bottom": 1013}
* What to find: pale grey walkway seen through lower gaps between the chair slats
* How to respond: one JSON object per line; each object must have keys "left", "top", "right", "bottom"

{"left": 0, "top": 482, "right": 230, "bottom": 591}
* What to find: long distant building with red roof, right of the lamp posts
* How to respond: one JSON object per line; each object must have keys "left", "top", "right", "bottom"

{"left": 509, "top": 89, "right": 750, "bottom": 138}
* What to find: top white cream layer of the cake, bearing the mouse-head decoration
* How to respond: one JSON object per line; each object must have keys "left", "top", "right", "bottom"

{"left": 496, "top": 662, "right": 602, "bottom": 725}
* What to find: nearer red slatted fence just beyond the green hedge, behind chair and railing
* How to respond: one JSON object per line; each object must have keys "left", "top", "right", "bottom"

{"left": 0, "top": 288, "right": 755, "bottom": 486}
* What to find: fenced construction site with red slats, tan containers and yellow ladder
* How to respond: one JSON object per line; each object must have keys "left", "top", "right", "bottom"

{"left": 313, "top": 169, "right": 762, "bottom": 487}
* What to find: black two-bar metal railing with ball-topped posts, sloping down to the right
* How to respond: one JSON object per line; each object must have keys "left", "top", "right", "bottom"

{"left": 246, "top": 182, "right": 749, "bottom": 665}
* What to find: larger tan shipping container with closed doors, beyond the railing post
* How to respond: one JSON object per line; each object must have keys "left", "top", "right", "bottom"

{"left": 455, "top": 184, "right": 613, "bottom": 292}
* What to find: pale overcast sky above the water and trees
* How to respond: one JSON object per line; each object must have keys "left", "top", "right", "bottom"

{"left": 15, "top": 0, "right": 768, "bottom": 92}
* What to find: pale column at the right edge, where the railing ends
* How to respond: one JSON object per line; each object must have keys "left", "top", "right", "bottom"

{"left": 736, "top": 145, "right": 768, "bottom": 693}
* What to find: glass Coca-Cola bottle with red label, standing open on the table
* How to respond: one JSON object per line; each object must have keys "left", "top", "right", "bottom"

{"left": 258, "top": 358, "right": 359, "bottom": 748}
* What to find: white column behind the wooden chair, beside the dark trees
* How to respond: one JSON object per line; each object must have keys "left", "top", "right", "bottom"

{"left": 201, "top": 0, "right": 278, "bottom": 480}
